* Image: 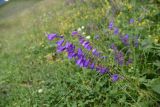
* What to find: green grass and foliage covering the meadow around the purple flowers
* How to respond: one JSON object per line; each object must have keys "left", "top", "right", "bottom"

{"left": 0, "top": 0, "right": 160, "bottom": 107}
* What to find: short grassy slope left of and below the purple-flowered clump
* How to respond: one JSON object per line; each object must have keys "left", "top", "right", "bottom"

{"left": 0, "top": 0, "right": 160, "bottom": 107}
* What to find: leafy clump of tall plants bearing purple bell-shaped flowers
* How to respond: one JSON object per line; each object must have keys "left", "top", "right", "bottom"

{"left": 47, "top": 1, "right": 159, "bottom": 106}
